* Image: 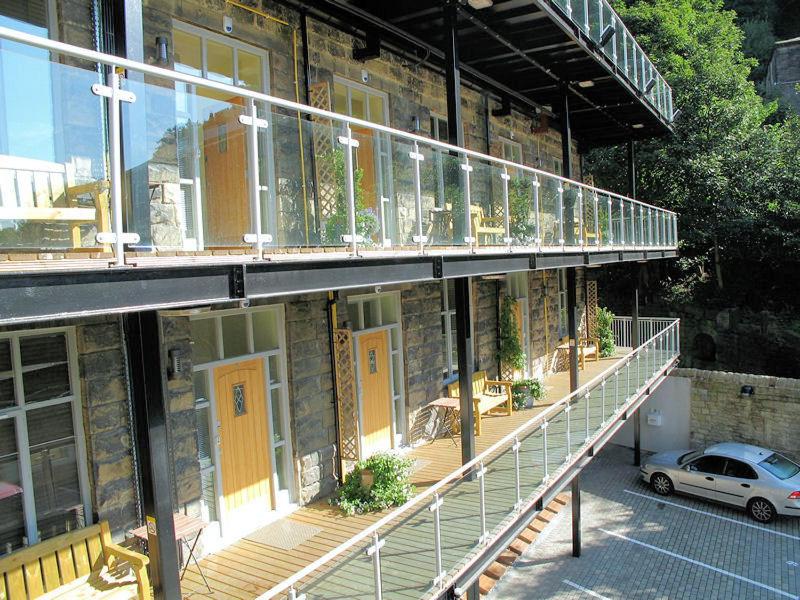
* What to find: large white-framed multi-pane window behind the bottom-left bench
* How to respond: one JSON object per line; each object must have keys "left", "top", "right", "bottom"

{"left": 0, "top": 329, "right": 91, "bottom": 554}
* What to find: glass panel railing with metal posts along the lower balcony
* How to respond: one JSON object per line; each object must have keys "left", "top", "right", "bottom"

{"left": 268, "top": 319, "right": 679, "bottom": 599}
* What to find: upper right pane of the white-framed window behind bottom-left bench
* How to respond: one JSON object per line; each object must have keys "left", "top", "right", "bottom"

{"left": 19, "top": 333, "right": 72, "bottom": 402}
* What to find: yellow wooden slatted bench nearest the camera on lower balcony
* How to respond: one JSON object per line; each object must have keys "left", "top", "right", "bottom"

{"left": 0, "top": 521, "right": 150, "bottom": 600}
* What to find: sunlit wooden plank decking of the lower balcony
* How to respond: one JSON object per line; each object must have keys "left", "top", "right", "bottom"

{"left": 183, "top": 358, "right": 632, "bottom": 599}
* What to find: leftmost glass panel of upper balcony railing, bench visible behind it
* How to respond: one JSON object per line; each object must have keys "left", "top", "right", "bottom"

{"left": 0, "top": 42, "right": 112, "bottom": 252}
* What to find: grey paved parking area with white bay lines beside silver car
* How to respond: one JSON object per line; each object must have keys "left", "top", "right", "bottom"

{"left": 489, "top": 445, "right": 800, "bottom": 600}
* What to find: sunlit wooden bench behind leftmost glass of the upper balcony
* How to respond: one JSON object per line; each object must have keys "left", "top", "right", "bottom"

{"left": 0, "top": 155, "right": 110, "bottom": 250}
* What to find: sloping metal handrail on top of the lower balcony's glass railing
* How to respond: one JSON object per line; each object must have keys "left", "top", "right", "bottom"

{"left": 258, "top": 319, "right": 680, "bottom": 600}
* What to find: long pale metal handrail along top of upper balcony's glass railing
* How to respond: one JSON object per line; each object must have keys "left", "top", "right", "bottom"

{"left": 0, "top": 27, "right": 677, "bottom": 217}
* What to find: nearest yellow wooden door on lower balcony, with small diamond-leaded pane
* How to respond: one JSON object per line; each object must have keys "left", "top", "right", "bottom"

{"left": 214, "top": 359, "right": 273, "bottom": 521}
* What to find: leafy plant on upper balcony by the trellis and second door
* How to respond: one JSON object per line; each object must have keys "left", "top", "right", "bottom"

{"left": 319, "top": 148, "right": 378, "bottom": 246}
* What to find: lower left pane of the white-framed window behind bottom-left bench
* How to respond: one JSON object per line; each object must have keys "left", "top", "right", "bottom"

{"left": 0, "top": 419, "right": 26, "bottom": 555}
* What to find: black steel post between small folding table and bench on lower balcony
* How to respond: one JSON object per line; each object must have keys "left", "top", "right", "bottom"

{"left": 455, "top": 277, "right": 475, "bottom": 464}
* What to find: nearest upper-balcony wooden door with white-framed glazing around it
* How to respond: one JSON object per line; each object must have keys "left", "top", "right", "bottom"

{"left": 173, "top": 22, "right": 277, "bottom": 249}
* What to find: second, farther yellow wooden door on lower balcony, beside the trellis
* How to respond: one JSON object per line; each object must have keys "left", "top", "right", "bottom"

{"left": 358, "top": 330, "right": 393, "bottom": 457}
